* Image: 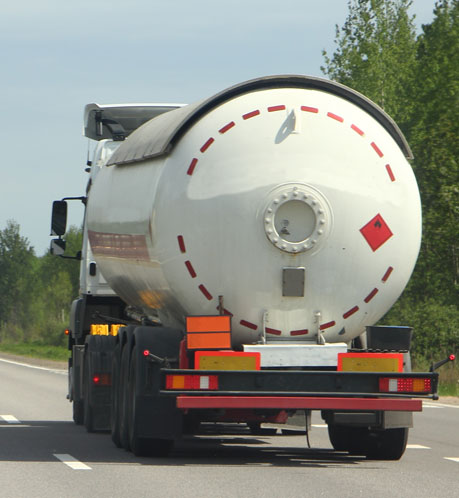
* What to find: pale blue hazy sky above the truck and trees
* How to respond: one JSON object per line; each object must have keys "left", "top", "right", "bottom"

{"left": 0, "top": 0, "right": 435, "bottom": 256}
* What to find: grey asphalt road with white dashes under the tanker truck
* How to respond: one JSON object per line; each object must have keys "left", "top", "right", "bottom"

{"left": 0, "top": 359, "right": 459, "bottom": 498}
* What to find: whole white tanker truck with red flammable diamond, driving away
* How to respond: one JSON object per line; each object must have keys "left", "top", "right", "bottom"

{"left": 52, "top": 76, "right": 446, "bottom": 459}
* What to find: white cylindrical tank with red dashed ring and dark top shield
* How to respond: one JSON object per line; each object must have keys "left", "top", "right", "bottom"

{"left": 87, "top": 76, "right": 421, "bottom": 344}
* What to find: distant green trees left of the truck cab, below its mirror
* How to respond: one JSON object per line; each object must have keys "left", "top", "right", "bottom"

{"left": 0, "top": 220, "right": 82, "bottom": 346}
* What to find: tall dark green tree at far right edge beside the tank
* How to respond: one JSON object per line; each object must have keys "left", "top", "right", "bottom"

{"left": 409, "top": 0, "right": 459, "bottom": 306}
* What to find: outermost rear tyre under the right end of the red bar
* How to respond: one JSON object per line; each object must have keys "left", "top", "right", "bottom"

{"left": 365, "top": 427, "right": 409, "bottom": 460}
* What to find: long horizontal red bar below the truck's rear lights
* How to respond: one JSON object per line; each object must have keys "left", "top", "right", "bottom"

{"left": 177, "top": 396, "right": 422, "bottom": 412}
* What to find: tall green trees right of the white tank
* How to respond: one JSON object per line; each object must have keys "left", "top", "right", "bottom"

{"left": 322, "top": 0, "right": 459, "bottom": 361}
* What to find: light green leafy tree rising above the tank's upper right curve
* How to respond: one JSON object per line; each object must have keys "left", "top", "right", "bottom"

{"left": 321, "top": 0, "right": 416, "bottom": 130}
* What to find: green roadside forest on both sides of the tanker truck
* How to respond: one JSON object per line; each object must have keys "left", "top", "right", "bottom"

{"left": 0, "top": 0, "right": 459, "bottom": 362}
